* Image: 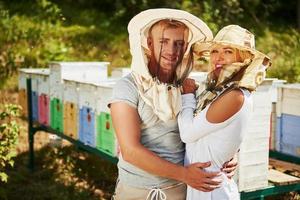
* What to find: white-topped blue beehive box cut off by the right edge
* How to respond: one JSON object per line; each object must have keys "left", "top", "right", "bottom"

{"left": 276, "top": 84, "right": 300, "bottom": 157}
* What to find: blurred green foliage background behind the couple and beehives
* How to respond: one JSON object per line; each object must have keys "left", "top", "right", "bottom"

{"left": 0, "top": 0, "right": 299, "bottom": 88}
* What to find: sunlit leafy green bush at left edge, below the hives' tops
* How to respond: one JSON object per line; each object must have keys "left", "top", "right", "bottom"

{"left": 0, "top": 104, "right": 20, "bottom": 182}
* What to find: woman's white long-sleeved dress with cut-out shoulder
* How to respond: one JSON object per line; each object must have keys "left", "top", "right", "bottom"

{"left": 178, "top": 89, "right": 253, "bottom": 200}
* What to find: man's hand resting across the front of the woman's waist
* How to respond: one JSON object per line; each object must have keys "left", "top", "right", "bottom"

{"left": 184, "top": 162, "right": 222, "bottom": 192}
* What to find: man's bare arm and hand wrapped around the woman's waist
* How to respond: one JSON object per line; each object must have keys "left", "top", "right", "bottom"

{"left": 111, "top": 102, "right": 220, "bottom": 191}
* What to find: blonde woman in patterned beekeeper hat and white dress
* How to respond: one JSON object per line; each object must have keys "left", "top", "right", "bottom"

{"left": 178, "top": 25, "right": 269, "bottom": 200}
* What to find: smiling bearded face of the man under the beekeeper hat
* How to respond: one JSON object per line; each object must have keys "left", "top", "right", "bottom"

{"left": 148, "top": 25, "right": 188, "bottom": 74}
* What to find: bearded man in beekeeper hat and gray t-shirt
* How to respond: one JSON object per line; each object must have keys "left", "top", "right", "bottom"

{"left": 110, "top": 9, "right": 236, "bottom": 200}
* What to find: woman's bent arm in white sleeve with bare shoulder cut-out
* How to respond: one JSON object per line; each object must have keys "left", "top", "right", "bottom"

{"left": 178, "top": 89, "right": 244, "bottom": 143}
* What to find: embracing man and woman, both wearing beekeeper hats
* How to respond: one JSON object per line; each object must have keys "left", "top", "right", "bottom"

{"left": 109, "top": 9, "right": 270, "bottom": 200}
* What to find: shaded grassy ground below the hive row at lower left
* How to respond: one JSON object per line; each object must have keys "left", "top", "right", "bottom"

{"left": 0, "top": 143, "right": 117, "bottom": 200}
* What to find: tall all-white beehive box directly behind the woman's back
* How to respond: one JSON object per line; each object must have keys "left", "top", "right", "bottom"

{"left": 236, "top": 80, "right": 272, "bottom": 191}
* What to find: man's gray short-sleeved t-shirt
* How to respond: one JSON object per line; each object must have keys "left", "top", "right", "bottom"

{"left": 110, "top": 74, "right": 184, "bottom": 188}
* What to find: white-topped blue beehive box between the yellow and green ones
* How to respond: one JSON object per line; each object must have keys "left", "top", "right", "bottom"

{"left": 78, "top": 83, "right": 96, "bottom": 147}
